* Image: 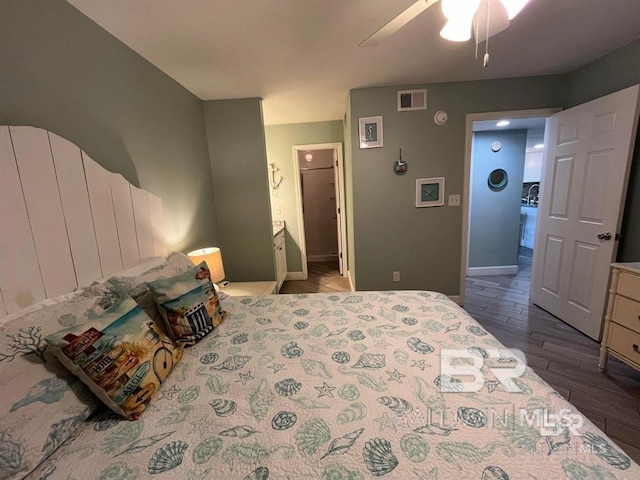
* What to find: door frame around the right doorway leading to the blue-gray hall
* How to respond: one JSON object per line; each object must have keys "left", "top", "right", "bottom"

{"left": 459, "top": 107, "right": 563, "bottom": 305}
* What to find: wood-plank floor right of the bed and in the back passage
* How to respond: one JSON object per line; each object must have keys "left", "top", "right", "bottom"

{"left": 280, "top": 249, "right": 640, "bottom": 463}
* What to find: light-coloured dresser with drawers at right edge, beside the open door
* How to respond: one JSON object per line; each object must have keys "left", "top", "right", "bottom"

{"left": 598, "top": 262, "right": 640, "bottom": 371}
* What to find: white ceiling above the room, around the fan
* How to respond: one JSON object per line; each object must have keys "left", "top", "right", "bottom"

{"left": 68, "top": 0, "right": 640, "bottom": 125}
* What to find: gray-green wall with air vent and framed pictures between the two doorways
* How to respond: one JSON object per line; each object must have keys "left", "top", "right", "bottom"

{"left": 347, "top": 76, "right": 563, "bottom": 295}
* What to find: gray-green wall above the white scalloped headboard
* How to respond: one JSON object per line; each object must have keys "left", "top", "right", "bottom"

{"left": 0, "top": 0, "right": 218, "bottom": 251}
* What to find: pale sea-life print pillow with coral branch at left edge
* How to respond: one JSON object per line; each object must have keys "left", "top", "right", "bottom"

{"left": 0, "top": 293, "right": 112, "bottom": 480}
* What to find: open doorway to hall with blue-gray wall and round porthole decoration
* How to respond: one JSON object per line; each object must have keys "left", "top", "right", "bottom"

{"left": 460, "top": 109, "right": 558, "bottom": 303}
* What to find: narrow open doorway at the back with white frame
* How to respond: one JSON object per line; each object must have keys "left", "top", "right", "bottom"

{"left": 294, "top": 143, "right": 347, "bottom": 278}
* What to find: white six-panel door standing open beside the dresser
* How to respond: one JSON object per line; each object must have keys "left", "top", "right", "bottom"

{"left": 531, "top": 85, "right": 639, "bottom": 340}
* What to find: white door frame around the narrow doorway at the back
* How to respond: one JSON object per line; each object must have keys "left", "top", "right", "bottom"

{"left": 287, "top": 142, "right": 348, "bottom": 280}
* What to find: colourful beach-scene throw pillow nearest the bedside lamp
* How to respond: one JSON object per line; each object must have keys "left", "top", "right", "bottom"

{"left": 148, "top": 262, "right": 225, "bottom": 346}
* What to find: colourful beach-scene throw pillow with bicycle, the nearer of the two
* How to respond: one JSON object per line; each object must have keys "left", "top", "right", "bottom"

{"left": 45, "top": 296, "right": 182, "bottom": 420}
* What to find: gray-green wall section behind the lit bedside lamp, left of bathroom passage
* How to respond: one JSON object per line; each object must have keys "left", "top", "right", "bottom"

{"left": 201, "top": 98, "right": 276, "bottom": 282}
